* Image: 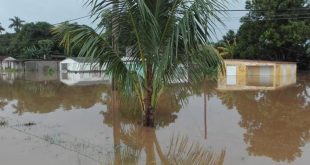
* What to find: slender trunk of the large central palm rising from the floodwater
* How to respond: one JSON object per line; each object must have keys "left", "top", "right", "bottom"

{"left": 144, "top": 63, "right": 154, "bottom": 127}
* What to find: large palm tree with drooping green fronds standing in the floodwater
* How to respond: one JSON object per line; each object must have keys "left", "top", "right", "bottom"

{"left": 54, "top": 0, "right": 226, "bottom": 126}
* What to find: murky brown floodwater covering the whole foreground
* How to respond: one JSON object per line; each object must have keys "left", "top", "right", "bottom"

{"left": 0, "top": 73, "right": 310, "bottom": 165}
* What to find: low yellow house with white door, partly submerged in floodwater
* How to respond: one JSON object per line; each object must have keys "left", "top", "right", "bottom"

{"left": 218, "top": 60, "right": 297, "bottom": 90}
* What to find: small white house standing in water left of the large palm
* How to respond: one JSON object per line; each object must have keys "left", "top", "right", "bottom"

{"left": 59, "top": 57, "right": 105, "bottom": 72}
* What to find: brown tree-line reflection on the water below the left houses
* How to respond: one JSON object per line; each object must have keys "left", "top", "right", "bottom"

{"left": 0, "top": 74, "right": 108, "bottom": 114}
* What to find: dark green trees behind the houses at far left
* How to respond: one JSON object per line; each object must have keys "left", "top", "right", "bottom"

{"left": 0, "top": 16, "right": 63, "bottom": 59}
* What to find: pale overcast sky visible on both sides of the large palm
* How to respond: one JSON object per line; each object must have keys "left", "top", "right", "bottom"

{"left": 0, "top": 0, "right": 246, "bottom": 40}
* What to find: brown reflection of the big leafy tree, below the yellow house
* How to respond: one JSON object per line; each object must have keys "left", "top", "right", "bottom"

{"left": 217, "top": 75, "right": 310, "bottom": 162}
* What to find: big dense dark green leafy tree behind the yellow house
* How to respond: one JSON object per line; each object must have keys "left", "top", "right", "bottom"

{"left": 236, "top": 0, "right": 310, "bottom": 68}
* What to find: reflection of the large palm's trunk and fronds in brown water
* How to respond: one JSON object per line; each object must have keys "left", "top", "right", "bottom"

{"left": 102, "top": 85, "right": 225, "bottom": 165}
